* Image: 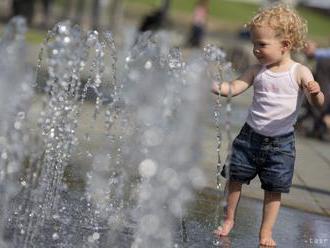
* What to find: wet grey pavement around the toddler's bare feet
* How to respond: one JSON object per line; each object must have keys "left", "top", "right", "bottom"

{"left": 187, "top": 190, "right": 330, "bottom": 248}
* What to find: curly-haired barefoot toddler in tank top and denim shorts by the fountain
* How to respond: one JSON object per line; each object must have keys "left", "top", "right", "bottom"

{"left": 212, "top": 5, "right": 324, "bottom": 246}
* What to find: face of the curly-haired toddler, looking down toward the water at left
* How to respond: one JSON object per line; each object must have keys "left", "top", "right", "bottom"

{"left": 251, "top": 27, "right": 286, "bottom": 65}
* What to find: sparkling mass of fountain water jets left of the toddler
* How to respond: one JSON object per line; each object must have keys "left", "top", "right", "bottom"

{"left": 0, "top": 17, "right": 235, "bottom": 247}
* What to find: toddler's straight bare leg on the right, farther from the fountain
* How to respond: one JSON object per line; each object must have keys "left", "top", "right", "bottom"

{"left": 259, "top": 190, "right": 281, "bottom": 246}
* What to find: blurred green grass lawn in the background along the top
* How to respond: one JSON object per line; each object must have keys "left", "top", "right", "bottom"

{"left": 125, "top": 0, "right": 330, "bottom": 44}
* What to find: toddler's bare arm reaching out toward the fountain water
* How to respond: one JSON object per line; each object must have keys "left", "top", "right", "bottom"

{"left": 212, "top": 65, "right": 260, "bottom": 96}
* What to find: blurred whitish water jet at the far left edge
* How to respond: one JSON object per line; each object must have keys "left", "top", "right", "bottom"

{"left": 0, "top": 17, "right": 38, "bottom": 247}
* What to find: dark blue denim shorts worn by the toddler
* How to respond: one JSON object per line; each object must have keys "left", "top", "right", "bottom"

{"left": 221, "top": 124, "right": 296, "bottom": 193}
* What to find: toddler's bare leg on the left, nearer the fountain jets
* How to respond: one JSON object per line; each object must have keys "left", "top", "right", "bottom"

{"left": 214, "top": 181, "right": 242, "bottom": 236}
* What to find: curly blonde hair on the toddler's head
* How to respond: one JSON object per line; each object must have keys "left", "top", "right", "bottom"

{"left": 247, "top": 4, "right": 307, "bottom": 50}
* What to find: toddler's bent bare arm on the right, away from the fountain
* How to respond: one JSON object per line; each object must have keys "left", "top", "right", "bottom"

{"left": 298, "top": 65, "right": 324, "bottom": 108}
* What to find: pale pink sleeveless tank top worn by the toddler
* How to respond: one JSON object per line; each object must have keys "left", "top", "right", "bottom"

{"left": 246, "top": 63, "right": 304, "bottom": 137}
